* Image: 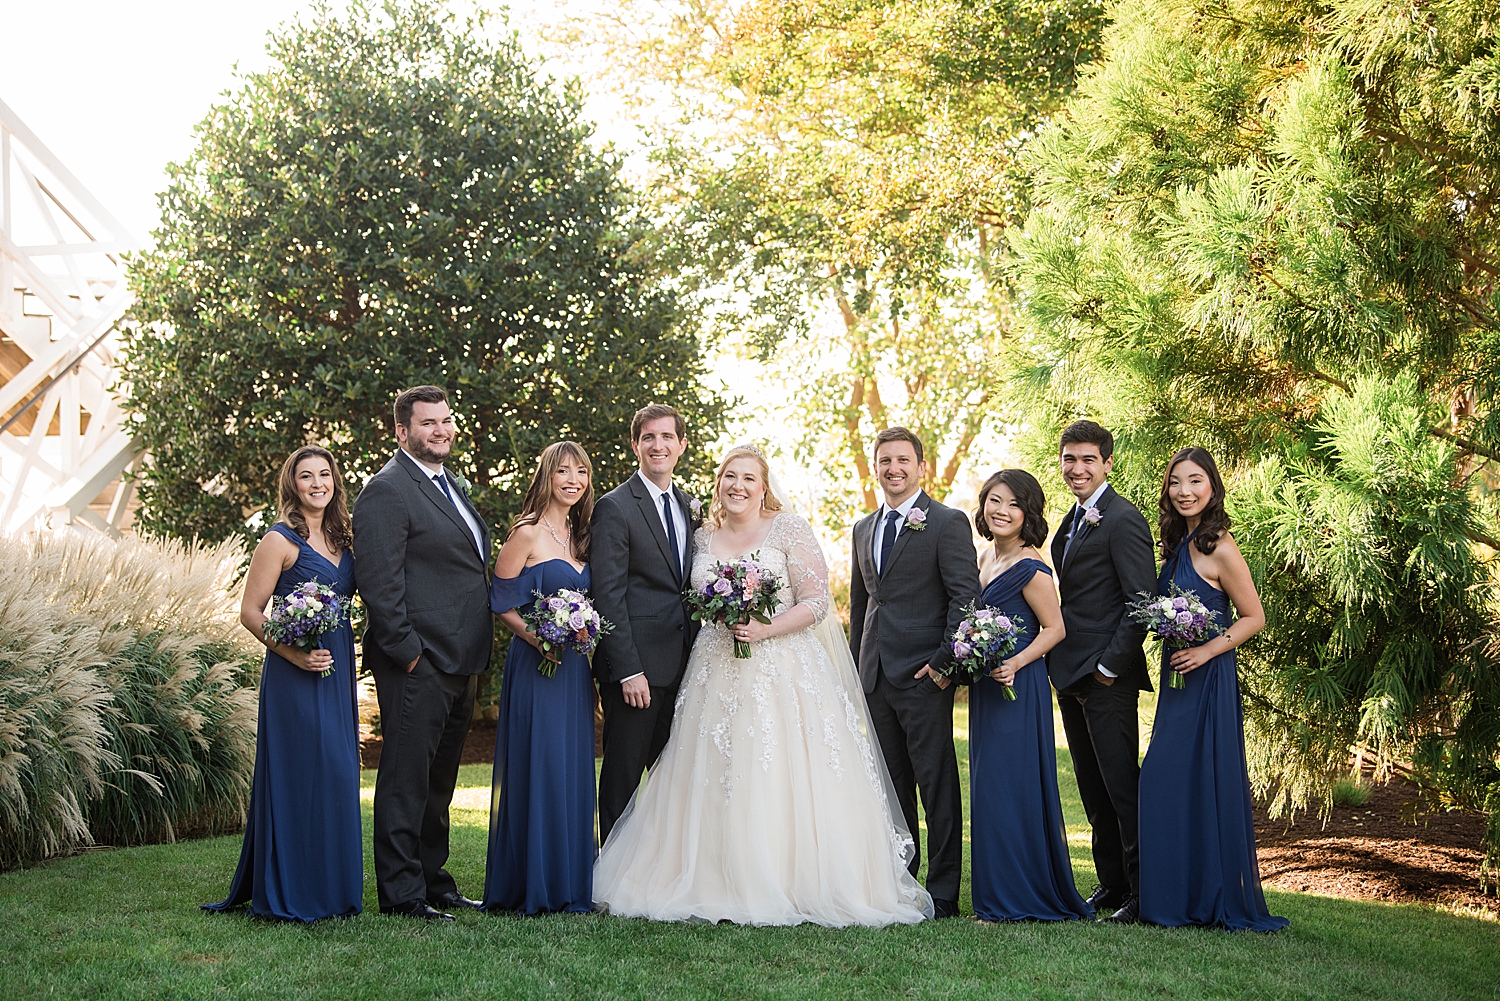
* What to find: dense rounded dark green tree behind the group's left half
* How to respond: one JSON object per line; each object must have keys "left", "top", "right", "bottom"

{"left": 126, "top": 0, "right": 723, "bottom": 549}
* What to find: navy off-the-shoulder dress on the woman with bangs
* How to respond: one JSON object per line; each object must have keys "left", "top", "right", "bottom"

{"left": 485, "top": 560, "right": 597, "bottom": 914}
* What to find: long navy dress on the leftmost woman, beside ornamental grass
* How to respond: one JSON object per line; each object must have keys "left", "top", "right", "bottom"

{"left": 204, "top": 522, "right": 365, "bottom": 921}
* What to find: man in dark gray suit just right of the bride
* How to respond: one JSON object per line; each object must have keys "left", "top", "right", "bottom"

{"left": 849, "top": 428, "right": 980, "bottom": 917}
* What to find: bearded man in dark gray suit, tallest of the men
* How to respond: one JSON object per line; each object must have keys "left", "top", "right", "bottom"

{"left": 354, "top": 386, "right": 494, "bottom": 920}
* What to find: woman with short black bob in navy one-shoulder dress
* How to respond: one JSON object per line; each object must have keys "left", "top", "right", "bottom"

{"left": 969, "top": 470, "right": 1094, "bottom": 923}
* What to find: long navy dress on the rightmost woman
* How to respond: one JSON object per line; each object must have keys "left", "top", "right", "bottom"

{"left": 1140, "top": 534, "right": 1289, "bottom": 932}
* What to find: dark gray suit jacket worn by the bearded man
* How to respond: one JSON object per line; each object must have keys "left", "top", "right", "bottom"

{"left": 354, "top": 452, "right": 495, "bottom": 675}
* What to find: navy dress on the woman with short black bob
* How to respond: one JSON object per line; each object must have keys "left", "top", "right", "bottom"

{"left": 969, "top": 560, "right": 1094, "bottom": 921}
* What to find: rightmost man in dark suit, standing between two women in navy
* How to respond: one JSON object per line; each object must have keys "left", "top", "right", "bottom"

{"left": 1047, "top": 420, "right": 1157, "bottom": 923}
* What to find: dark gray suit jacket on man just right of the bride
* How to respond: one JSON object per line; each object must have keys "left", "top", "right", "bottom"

{"left": 849, "top": 491, "right": 980, "bottom": 693}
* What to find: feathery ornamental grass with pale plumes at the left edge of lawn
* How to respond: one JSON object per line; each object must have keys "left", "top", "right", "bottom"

{"left": 0, "top": 536, "right": 258, "bottom": 867}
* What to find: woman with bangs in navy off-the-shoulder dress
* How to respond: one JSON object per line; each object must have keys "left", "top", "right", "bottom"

{"left": 483, "top": 441, "right": 597, "bottom": 914}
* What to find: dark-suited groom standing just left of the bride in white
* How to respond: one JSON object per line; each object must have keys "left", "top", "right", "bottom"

{"left": 590, "top": 404, "right": 699, "bottom": 845}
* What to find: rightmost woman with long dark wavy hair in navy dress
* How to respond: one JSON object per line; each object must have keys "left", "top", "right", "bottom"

{"left": 1140, "top": 449, "right": 1287, "bottom": 932}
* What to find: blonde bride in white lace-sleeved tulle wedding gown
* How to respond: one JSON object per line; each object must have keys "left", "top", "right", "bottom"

{"left": 594, "top": 446, "right": 933, "bottom": 927}
